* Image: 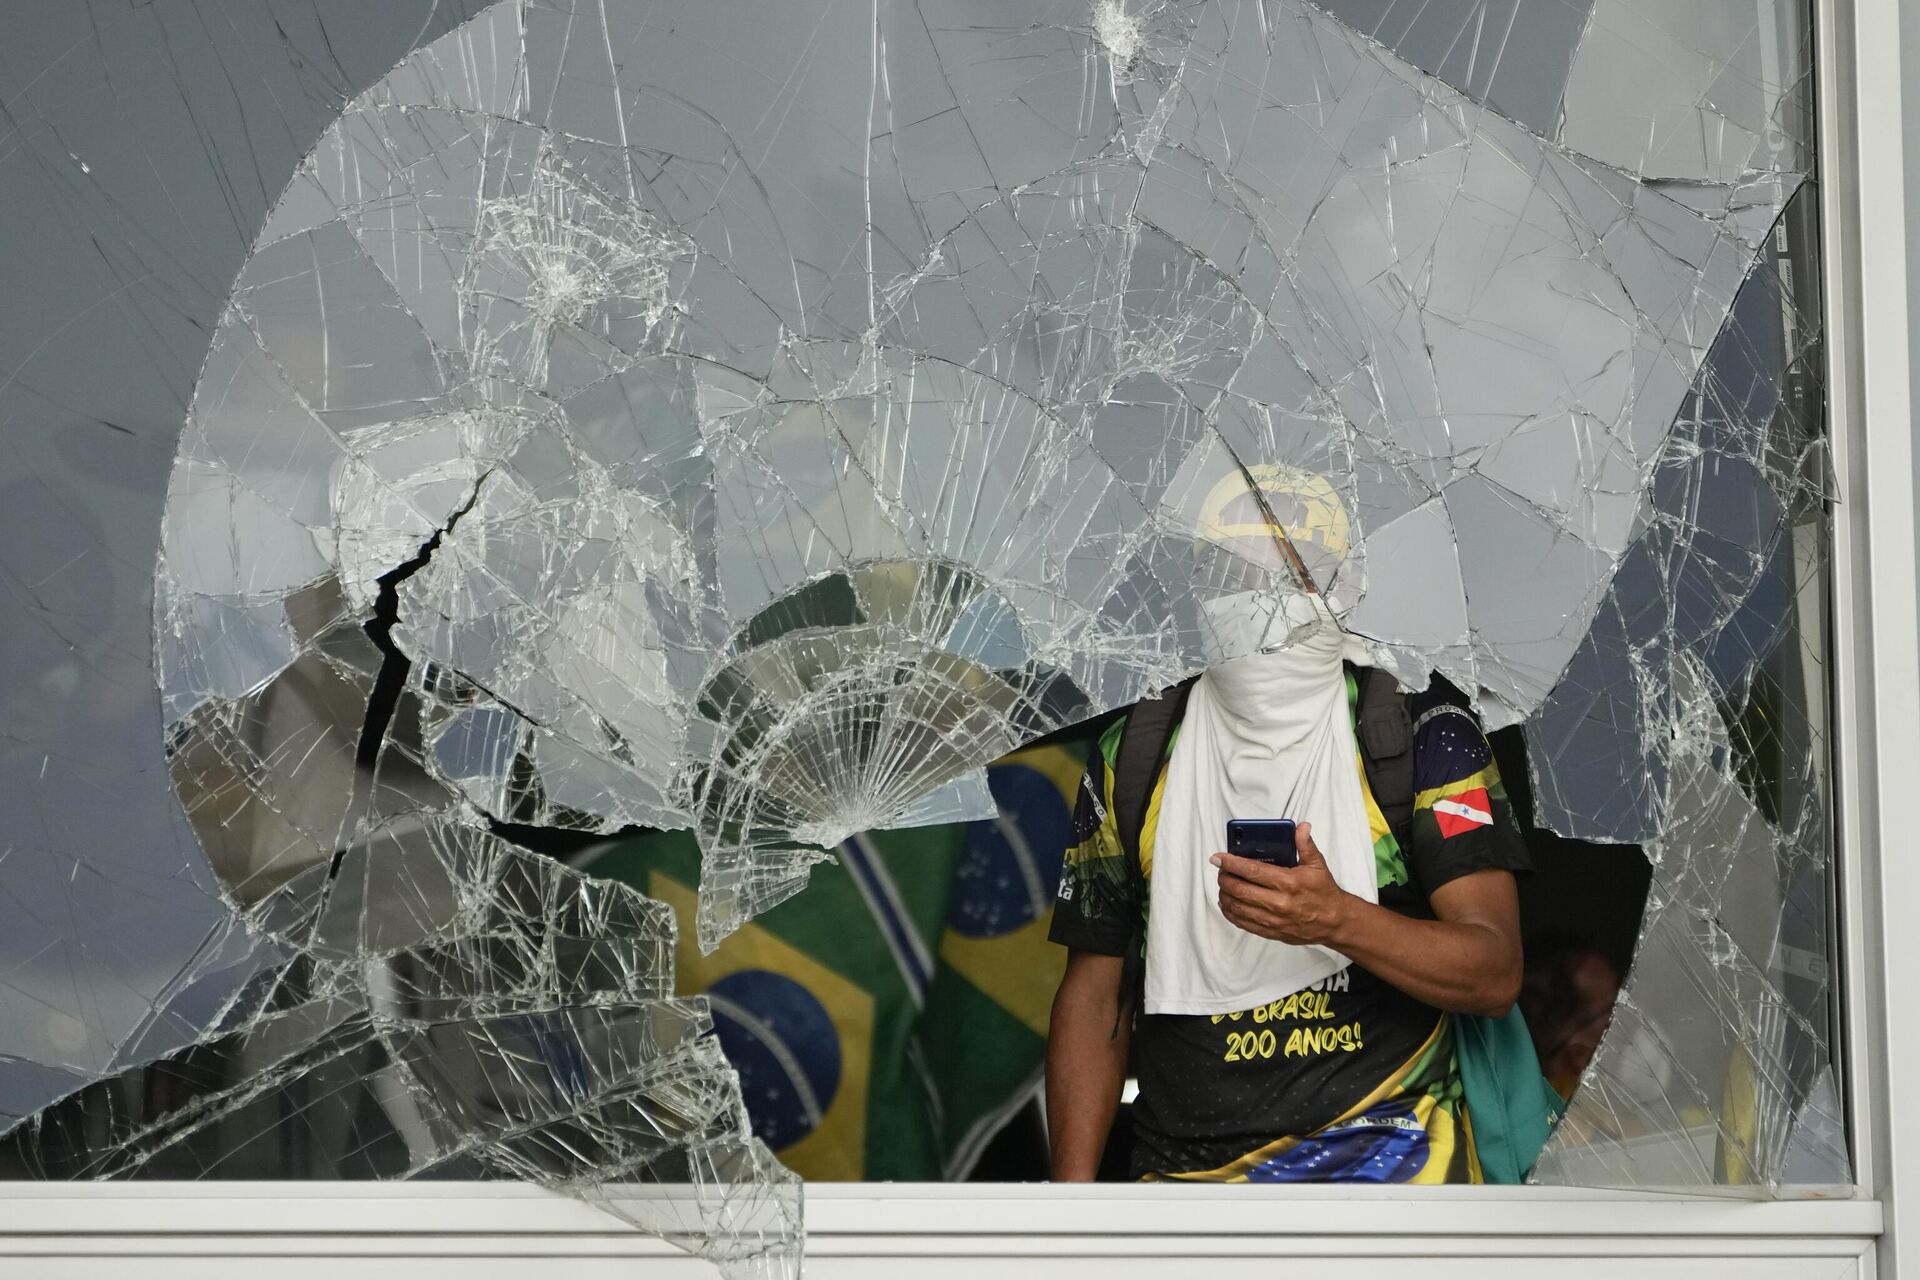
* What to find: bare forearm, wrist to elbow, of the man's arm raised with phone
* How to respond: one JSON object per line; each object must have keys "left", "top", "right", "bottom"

{"left": 1329, "top": 898, "right": 1521, "bottom": 1017}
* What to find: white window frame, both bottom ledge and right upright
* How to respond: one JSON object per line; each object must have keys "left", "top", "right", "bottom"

{"left": 0, "top": 0, "right": 1920, "bottom": 1280}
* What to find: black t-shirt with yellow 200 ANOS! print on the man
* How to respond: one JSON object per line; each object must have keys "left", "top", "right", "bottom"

{"left": 1050, "top": 679, "right": 1528, "bottom": 1182}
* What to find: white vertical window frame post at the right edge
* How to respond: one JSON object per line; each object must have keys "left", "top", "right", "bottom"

{"left": 1814, "top": 0, "right": 1920, "bottom": 1276}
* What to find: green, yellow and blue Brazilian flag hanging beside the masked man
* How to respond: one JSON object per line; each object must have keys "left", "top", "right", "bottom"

{"left": 586, "top": 741, "right": 1089, "bottom": 1182}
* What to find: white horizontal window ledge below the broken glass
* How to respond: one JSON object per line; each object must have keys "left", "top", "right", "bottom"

{"left": 0, "top": 1182, "right": 1882, "bottom": 1280}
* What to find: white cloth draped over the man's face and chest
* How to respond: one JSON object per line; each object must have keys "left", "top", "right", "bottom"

{"left": 1144, "top": 595, "right": 1379, "bottom": 1013}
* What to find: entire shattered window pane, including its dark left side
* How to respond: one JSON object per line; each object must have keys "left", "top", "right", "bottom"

{"left": 0, "top": 0, "right": 1851, "bottom": 1272}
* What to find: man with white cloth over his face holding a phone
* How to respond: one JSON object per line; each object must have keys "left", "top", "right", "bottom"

{"left": 1046, "top": 466, "right": 1526, "bottom": 1182}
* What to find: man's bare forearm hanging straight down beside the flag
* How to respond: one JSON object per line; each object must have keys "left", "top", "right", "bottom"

{"left": 1046, "top": 958, "right": 1133, "bottom": 1182}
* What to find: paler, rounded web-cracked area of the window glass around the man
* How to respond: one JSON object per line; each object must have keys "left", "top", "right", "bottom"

{"left": 0, "top": 0, "right": 1845, "bottom": 1274}
